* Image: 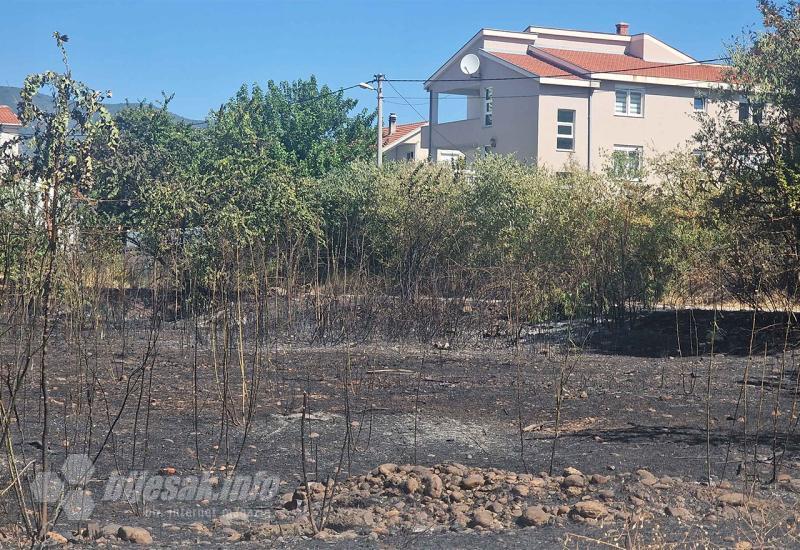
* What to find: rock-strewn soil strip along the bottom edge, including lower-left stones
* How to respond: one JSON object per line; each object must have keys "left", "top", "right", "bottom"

{"left": 17, "top": 462, "right": 800, "bottom": 550}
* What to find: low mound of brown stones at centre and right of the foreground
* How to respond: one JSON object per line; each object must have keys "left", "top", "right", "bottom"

{"left": 243, "top": 463, "right": 800, "bottom": 548}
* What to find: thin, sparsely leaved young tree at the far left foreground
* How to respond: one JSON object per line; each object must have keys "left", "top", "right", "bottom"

{"left": 0, "top": 32, "right": 118, "bottom": 540}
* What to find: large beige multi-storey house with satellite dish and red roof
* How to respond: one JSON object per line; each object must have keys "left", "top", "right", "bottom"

{"left": 422, "top": 23, "right": 725, "bottom": 174}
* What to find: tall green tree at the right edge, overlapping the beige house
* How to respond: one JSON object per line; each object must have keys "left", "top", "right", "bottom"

{"left": 697, "top": 0, "right": 800, "bottom": 303}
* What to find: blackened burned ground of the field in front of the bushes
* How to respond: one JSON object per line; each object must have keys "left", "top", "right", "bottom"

{"left": 4, "top": 312, "right": 800, "bottom": 547}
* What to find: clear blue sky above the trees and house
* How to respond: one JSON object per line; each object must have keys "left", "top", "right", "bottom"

{"left": 0, "top": 0, "right": 759, "bottom": 122}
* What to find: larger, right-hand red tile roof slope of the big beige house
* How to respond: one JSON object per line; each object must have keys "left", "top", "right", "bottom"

{"left": 536, "top": 48, "right": 727, "bottom": 82}
